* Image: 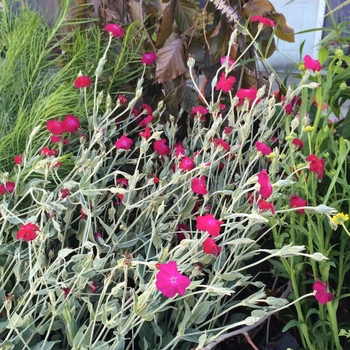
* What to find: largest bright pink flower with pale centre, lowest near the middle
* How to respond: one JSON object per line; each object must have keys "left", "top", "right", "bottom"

{"left": 156, "top": 261, "right": 191, "bottom": 298}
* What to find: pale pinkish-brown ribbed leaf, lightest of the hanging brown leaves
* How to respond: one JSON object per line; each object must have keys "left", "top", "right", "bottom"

{"left": 156, "top": 37, "right": 187, "bottom": 83}
